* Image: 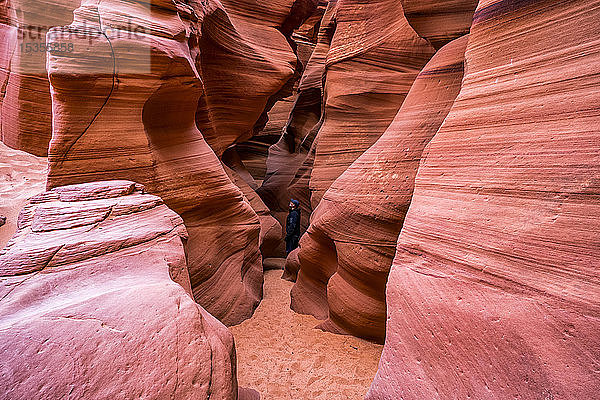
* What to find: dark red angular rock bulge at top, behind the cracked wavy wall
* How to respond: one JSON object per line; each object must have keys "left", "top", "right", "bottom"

{"left": 198, "top": 0, "right": 317, "bottom": 156}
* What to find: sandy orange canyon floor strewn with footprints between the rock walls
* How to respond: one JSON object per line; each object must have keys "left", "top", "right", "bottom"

{"left": 230, "top": 270, "right": 383, "bottom": 400}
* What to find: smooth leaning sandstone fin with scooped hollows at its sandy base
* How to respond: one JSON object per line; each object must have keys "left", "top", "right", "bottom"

{"left": 289, "top": 37, "right": 467, "bottom": 342}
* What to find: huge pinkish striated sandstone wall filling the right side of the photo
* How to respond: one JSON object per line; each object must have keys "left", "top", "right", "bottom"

{"left": 367, "top": 0, "right": 600, "bottom": 400}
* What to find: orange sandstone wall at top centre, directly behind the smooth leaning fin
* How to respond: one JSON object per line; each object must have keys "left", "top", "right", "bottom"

{"left": 310, "top": 0, "right": 434, "bottom": 208}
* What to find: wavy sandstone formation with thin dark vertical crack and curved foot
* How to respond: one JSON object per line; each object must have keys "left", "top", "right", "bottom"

{"left": 48, "top": 0, "right": 262, "bottom": 324}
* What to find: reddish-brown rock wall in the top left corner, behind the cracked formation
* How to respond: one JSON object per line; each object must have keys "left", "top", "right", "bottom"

{"left": 0, "top": 0, "right": 80, "bottom": 156}
